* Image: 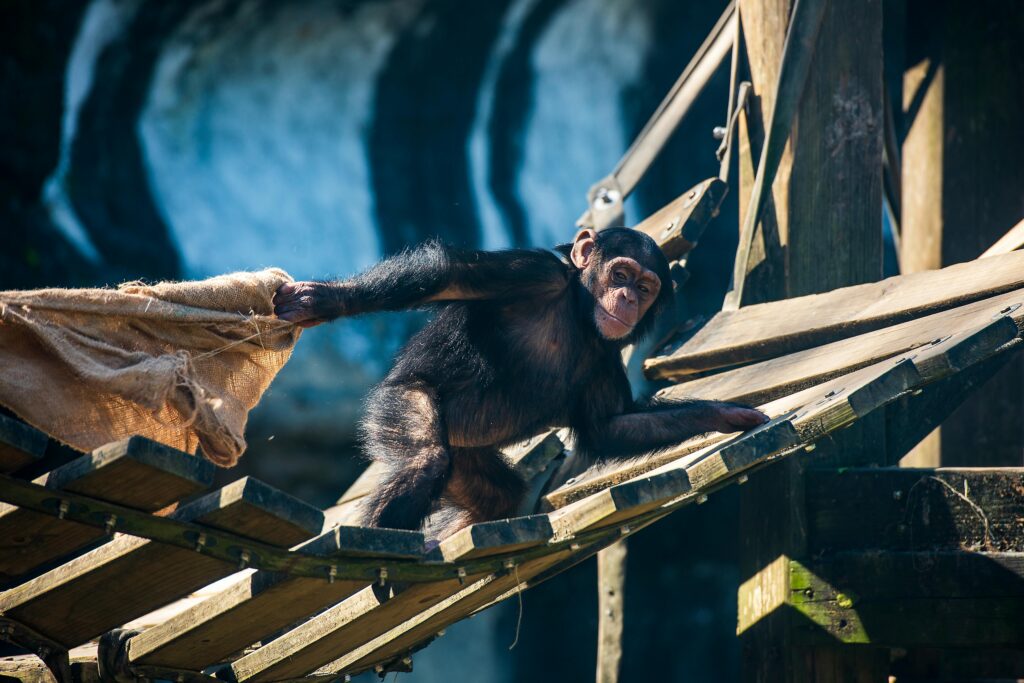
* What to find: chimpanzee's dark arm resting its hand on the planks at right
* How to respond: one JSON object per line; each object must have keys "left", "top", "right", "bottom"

{"left": 577, "top": 400, "right": 768, "bottom": 458}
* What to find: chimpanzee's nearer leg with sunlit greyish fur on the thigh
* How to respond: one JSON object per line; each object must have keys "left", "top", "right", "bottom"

{"left": 361, "top": 384, "right": 452, "bottom": 530}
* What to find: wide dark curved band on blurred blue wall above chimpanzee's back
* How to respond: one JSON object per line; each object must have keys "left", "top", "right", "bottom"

{"left": 370, "top": 0, "right": 508, "bottom": 253}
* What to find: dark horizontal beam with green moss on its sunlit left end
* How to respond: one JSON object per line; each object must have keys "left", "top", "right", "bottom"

{"left": 790, "top": 552, "right": 1024, "bottom": 647}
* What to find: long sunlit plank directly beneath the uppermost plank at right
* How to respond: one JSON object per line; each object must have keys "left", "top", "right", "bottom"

{"left": 658, "top": 291, "right": 1024, "bottom": 403}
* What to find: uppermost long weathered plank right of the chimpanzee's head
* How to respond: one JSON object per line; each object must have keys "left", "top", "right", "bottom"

{"left": 645, "top": 253, "right": 1024, "bottom": 379}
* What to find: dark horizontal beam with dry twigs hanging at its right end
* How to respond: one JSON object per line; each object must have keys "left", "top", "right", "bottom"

{"left": 805, "top": 467, "right": 1024, "bottom": 555}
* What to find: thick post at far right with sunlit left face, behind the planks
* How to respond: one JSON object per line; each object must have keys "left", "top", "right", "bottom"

{"left": 901, "top": 0, "right": 1024, "bottom": 467}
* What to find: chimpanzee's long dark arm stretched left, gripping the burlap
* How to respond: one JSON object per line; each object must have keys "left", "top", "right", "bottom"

{"left": 273, "top": 242, "right": 568, "bottom": 325}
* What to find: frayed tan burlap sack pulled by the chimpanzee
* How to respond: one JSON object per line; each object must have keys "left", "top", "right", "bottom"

{"left": 0, "top": 269, "right": 300, "bottom": 467}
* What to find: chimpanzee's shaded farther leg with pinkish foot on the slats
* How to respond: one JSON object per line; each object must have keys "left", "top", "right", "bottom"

{"left": 439, "top": 447, "right": 526, "bottom": 539}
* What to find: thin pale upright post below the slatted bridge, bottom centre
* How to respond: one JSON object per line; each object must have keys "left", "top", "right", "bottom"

{"left": 597, "top": 539, "right": 627, "bottom": 683}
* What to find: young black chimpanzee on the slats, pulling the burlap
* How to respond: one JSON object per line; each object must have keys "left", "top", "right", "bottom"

{"left": 274, "top": 228, "right": 768, "bottom": 537}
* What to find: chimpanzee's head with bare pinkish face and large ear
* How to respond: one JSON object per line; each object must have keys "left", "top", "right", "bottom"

{"left": 569, "top": 227, "right": 673, "bottom": 343}
